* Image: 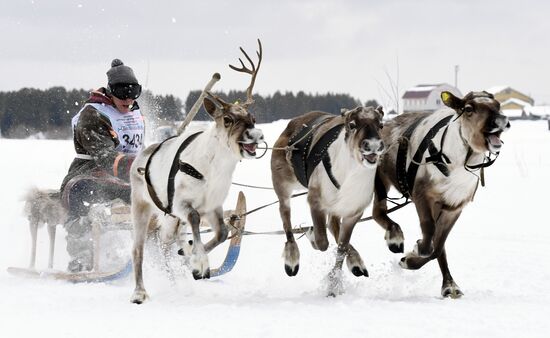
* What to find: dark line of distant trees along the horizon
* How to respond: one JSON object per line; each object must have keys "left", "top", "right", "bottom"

{"left": 0, "top": 87, "right": 377, "bottom": 139}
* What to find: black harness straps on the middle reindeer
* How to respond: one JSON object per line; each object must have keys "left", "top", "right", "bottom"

{"left": 288, "top": 115, "right": 344, "bottom": 189}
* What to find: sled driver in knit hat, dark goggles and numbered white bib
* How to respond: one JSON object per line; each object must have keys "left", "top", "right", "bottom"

{"left": 61, "top": 59, "right": 144, "bottom": 272}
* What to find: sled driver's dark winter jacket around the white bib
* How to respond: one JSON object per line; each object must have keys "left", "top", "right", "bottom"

{"left": 61, "top": 88, "right": 142, "bottom": 192}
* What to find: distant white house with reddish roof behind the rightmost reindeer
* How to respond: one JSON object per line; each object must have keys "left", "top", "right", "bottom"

{"left": 402, "top": 83, "right": 462, "bottom": 113}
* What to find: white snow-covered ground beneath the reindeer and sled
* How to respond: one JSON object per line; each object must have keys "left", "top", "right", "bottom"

{"left": 0, "top": 121, "right": 550, "bottom": 337}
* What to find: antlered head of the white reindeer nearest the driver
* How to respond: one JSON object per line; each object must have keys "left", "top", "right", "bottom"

{"left": 204, "top": 39, "right": 264, "bottom": 158}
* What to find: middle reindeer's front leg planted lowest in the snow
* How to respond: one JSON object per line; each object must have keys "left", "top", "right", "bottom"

{"left": 328, "top": 213, "right": 362, "bottom": 297}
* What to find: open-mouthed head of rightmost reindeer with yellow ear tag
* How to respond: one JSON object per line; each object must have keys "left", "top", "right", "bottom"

{"left": 441, "top": 91, "right": 510, "bottom": 153}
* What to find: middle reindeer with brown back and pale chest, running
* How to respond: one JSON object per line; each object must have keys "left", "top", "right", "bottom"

{"left": 271, "top": 107, "right": 384, "bottom": 296}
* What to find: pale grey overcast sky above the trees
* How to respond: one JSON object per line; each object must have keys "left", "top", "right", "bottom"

{"left": 0, "top": 0, "right": 550, "bottom": 111}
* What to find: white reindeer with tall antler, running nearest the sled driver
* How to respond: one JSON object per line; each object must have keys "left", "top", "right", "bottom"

{"left": 130, "top": 40, "right": 264, "bottom": 304}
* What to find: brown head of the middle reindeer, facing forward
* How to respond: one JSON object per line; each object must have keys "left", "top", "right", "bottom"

{"left": 342, "top": 107, "right": 384, "bottom": 168}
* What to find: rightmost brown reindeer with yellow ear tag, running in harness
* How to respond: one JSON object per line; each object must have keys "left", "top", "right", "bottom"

{"left": 373, "top": 91, "right": 510, "bottom": 298}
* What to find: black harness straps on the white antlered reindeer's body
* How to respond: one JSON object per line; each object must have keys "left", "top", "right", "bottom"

{"left": 138, "top": 131, "right": 204, "bottom": 216}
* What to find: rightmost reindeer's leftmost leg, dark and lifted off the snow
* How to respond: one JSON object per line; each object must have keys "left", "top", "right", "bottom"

{"left": 372, "top": 173, "right": 405, "bottom": 253}
